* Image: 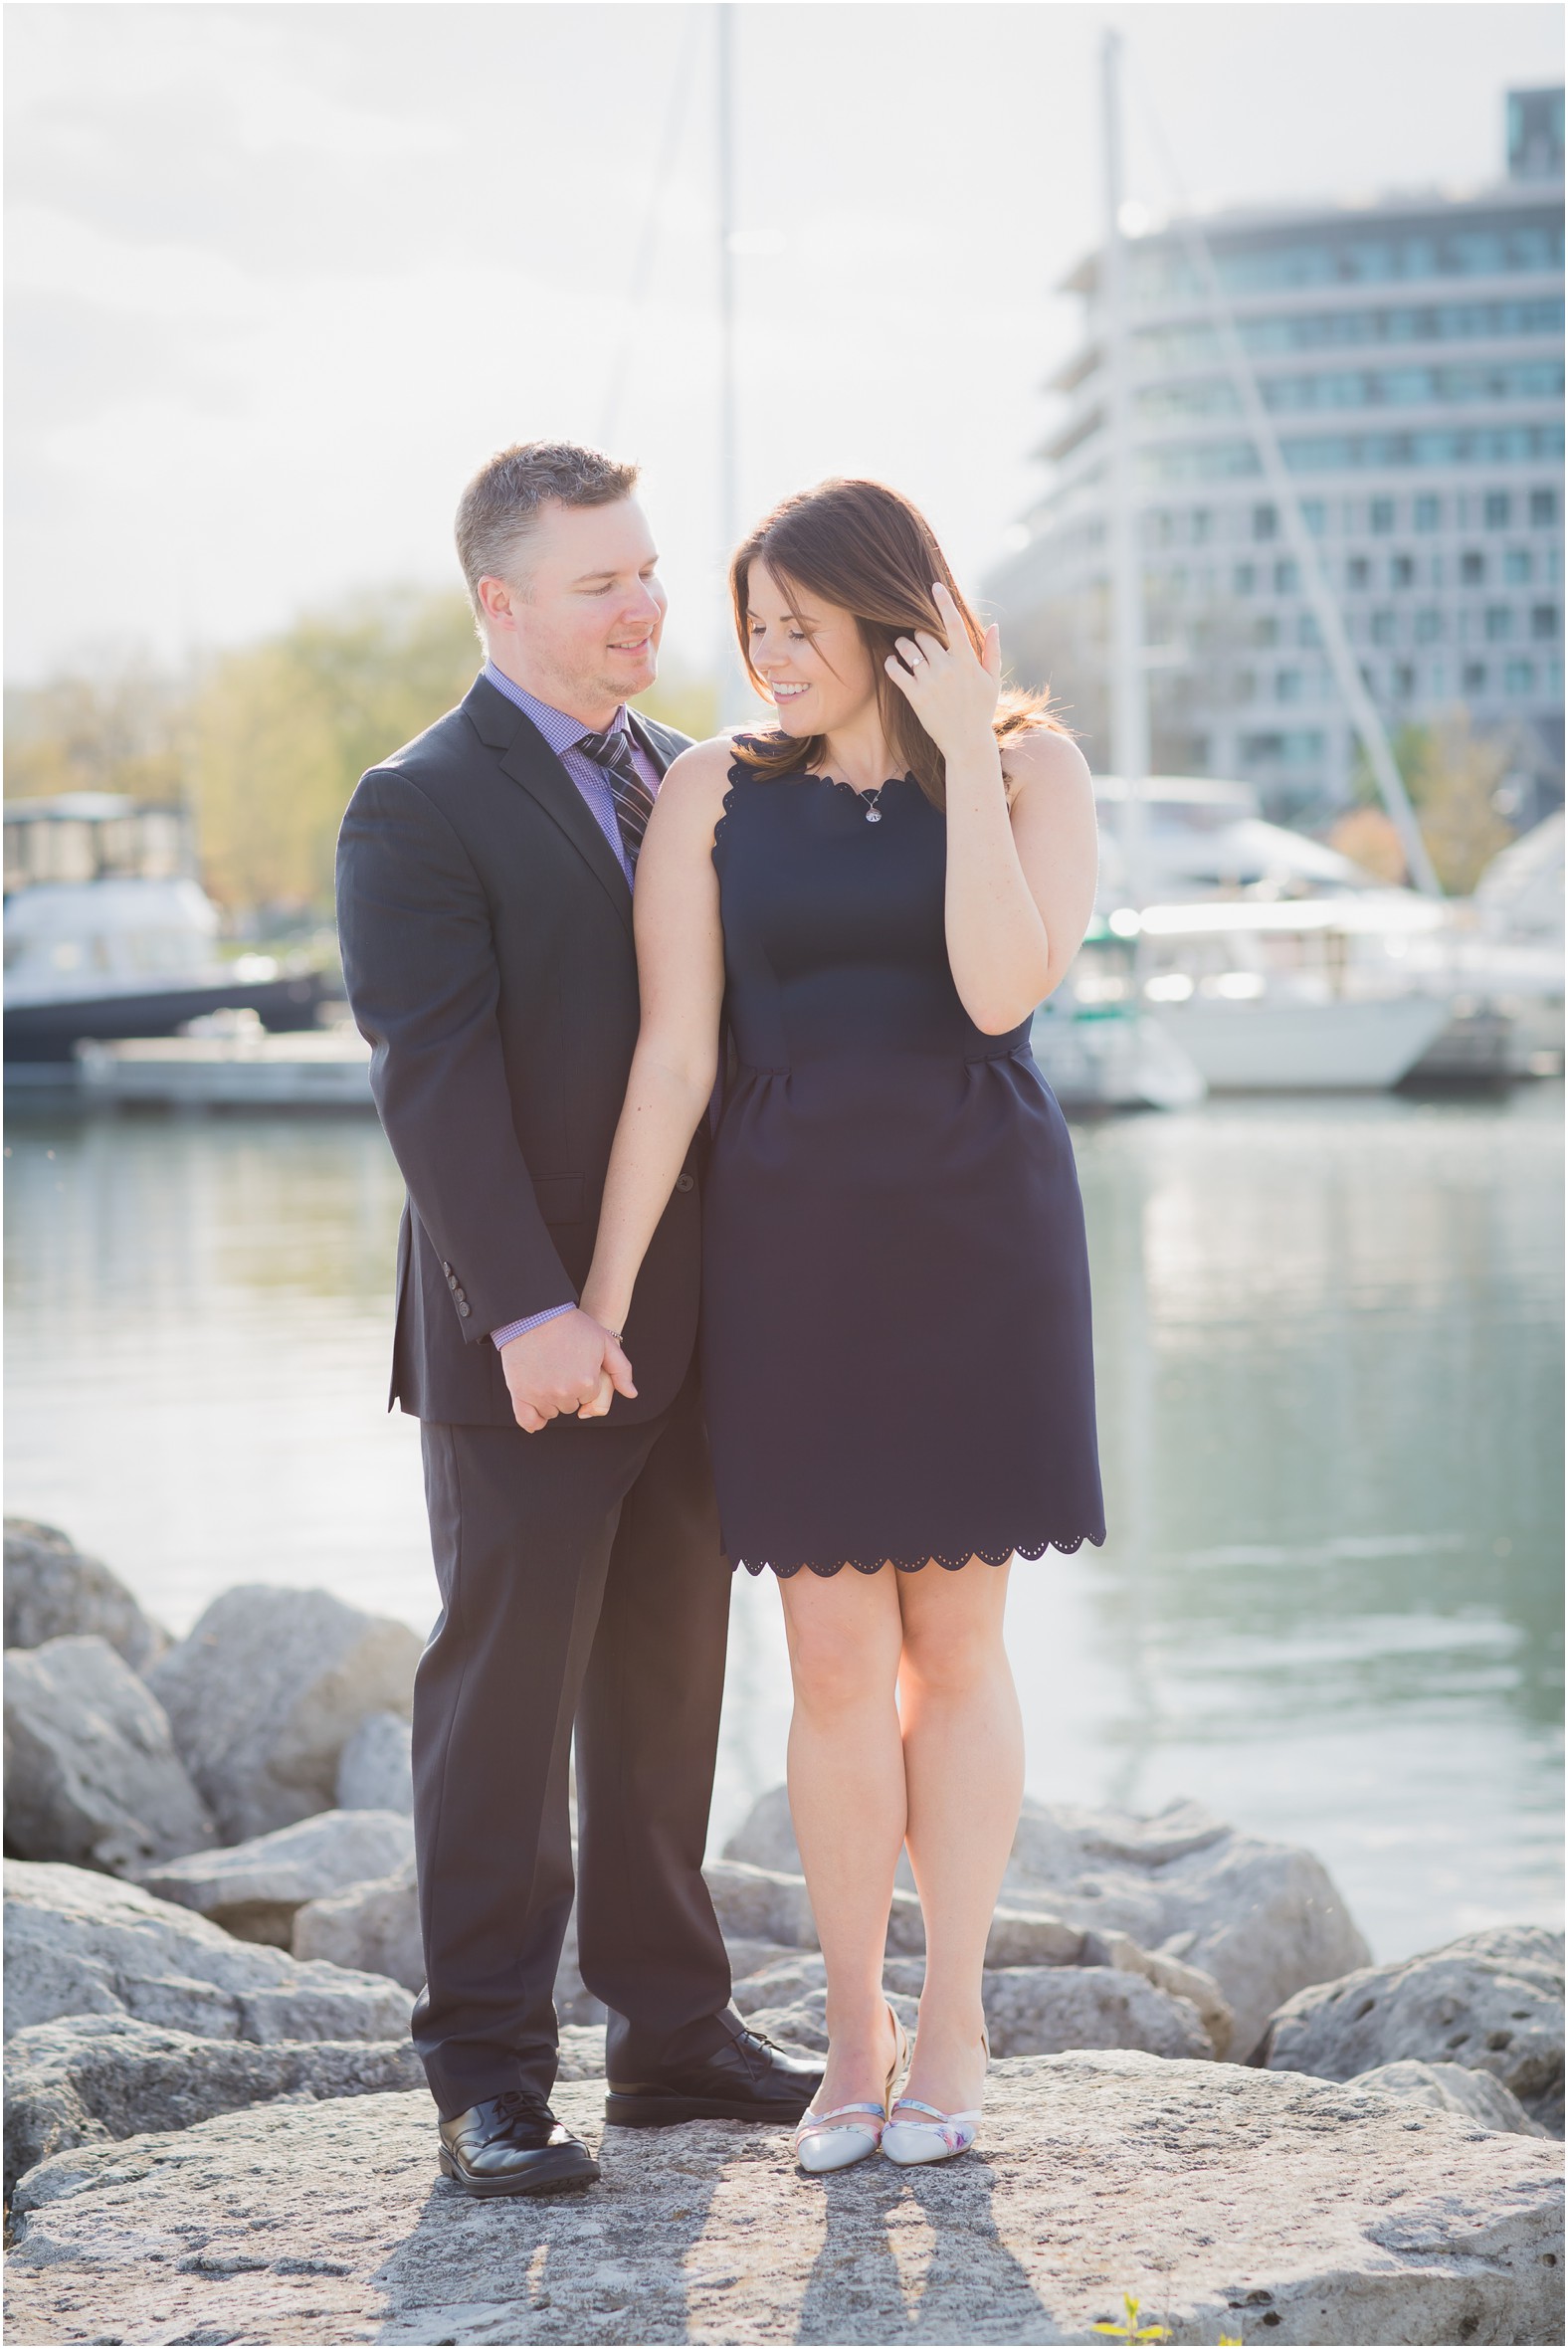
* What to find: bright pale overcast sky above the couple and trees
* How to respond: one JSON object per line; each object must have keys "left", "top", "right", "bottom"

{"left": 7, "top": 0, "right": 1563, "bottom": 679}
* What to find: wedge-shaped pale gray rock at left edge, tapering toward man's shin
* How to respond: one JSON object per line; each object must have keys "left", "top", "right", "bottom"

{"left": 5, "top": 1860, "right": 411, "bottom": 2044}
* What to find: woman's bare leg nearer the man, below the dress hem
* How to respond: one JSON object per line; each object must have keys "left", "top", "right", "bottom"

{"left": 779, "top": 1567, "right": 903, "bottom": 2112}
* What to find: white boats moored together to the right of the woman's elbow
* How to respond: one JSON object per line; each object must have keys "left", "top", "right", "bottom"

{"left": 1033, "top": 775, "right": 1563, "bottom": 1111}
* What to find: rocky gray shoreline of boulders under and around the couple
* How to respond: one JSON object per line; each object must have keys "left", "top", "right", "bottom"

{"left": 5, "top": 1522, "right": 1563, "bottom": 2342}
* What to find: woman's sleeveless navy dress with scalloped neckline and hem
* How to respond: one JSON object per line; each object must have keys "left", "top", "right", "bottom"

{"left": 701, "top": 766, "right": 1105, "bottom": 1574}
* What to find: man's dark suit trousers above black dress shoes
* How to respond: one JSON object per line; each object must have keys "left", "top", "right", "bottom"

{"left": 413, "top": 1369, "right": 739, "bottom": 2116}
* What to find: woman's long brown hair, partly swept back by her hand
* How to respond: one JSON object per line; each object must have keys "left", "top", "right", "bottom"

{"left": 730, "top": 480, "right": 1066, "bottom": 808}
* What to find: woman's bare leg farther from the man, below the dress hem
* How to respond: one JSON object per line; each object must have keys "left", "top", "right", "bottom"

{"left": 899, "top": 1557, "right": 1024, "bottom": 2112}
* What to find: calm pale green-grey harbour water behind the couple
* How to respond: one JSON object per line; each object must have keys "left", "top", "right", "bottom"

{"left": 5, "top": 1085, "right": 1563, "bottom": 1957}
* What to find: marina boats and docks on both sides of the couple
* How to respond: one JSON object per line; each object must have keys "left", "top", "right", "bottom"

{"left": 5, "top": 775, "right": 1563, "bottom": 1111}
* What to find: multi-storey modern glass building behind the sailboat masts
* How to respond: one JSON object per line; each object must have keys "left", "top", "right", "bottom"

{"left": 986, "top": 90, "right": 1563, "bottom": 822}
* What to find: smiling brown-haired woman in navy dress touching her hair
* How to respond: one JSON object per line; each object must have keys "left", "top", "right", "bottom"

{"left": 582, "top": 482, "right": 1103, "bottom": 2171}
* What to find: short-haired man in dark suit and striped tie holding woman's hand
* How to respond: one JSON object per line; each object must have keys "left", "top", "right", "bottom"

{"left": 338, "top": 442, "right": 819, "bottom": 2194}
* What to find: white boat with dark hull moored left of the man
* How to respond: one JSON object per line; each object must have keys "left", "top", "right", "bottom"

{"left": 5, "top": 792, "right": 326, "bottom": 1065}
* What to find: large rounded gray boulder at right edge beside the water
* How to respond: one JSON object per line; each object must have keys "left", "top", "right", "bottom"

{"left": 1254, "top": 1924, "right": 1563, "bottom": 2135}
